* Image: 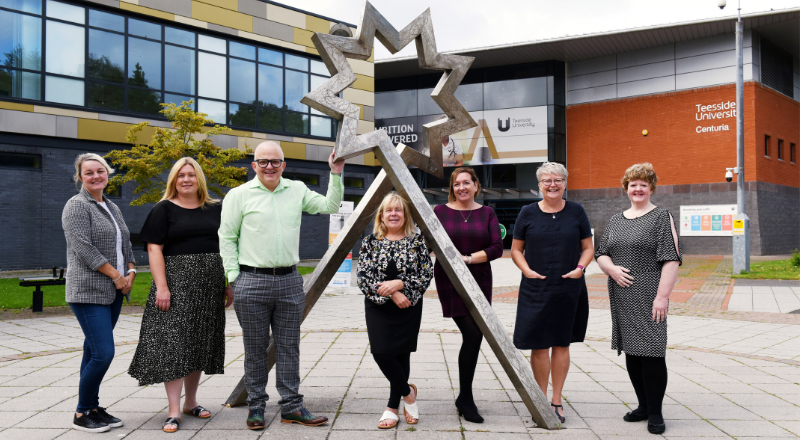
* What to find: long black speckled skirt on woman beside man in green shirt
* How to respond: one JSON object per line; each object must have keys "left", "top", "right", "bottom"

{"left": 128, "top": 254, "right": 225, "bottom": 386}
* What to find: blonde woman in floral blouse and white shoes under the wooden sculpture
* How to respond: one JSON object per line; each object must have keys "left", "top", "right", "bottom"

{"left": 358, "top": 193, "right": 433, "bottom": 429}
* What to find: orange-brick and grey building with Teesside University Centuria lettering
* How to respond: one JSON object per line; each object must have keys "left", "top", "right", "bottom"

{"left": 375, "top": 9, "right": 800, "bottom": 255}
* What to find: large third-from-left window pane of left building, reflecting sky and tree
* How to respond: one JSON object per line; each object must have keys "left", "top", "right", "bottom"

{"left": 86, "top": 29, "right": 125, "bottom": 84}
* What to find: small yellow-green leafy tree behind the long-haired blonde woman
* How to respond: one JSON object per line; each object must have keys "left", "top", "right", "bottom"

{"left": 106, "top": 101, "right": 247, "bottom": 206}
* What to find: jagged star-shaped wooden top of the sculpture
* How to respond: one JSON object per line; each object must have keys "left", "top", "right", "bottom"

{"left": 300, "top": 1, "right": 478, "bottom": 177}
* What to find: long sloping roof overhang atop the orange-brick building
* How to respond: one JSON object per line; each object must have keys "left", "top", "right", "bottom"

{"left": 375, "top": 8, "right": 800, "bottom": 79}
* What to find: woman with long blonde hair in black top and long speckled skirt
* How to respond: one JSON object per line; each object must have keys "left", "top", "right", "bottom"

{"left": 128, "top": 157, "right": 233, "bottom": 432}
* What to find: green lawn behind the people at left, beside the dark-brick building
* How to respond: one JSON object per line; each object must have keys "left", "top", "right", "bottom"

{"left": 0, "top": 266, "right": 314, "bottom": 310}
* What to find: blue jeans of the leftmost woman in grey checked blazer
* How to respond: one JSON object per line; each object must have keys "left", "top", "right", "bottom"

{"left": 69, "top": 290, "right": 122, "bottom": 412}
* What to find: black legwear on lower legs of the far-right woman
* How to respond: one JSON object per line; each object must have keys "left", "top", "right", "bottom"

{"left": 625, "top": 353, "right": 667, "bottom": 423}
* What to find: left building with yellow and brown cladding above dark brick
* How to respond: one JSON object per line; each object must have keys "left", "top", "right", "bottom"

{"left": 0, "top": 0, "right": 376, "bottom": 270}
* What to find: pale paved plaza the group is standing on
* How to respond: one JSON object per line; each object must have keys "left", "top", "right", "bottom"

{"left": 0, "top": 259, "right": 800, "bottom": 440}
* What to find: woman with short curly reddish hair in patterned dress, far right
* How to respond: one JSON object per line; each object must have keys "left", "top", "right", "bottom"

{"left": 595, "top": 163, "right": 681, "bottom": 434}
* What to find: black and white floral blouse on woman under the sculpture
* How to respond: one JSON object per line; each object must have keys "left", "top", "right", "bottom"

{"left": 358, "top": 234, "right": 433, "bottom": 306}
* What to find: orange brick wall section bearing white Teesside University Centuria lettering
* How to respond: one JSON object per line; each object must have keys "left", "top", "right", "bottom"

{"left": 567, "top": 82, "right": 800, "bottom": 189}
